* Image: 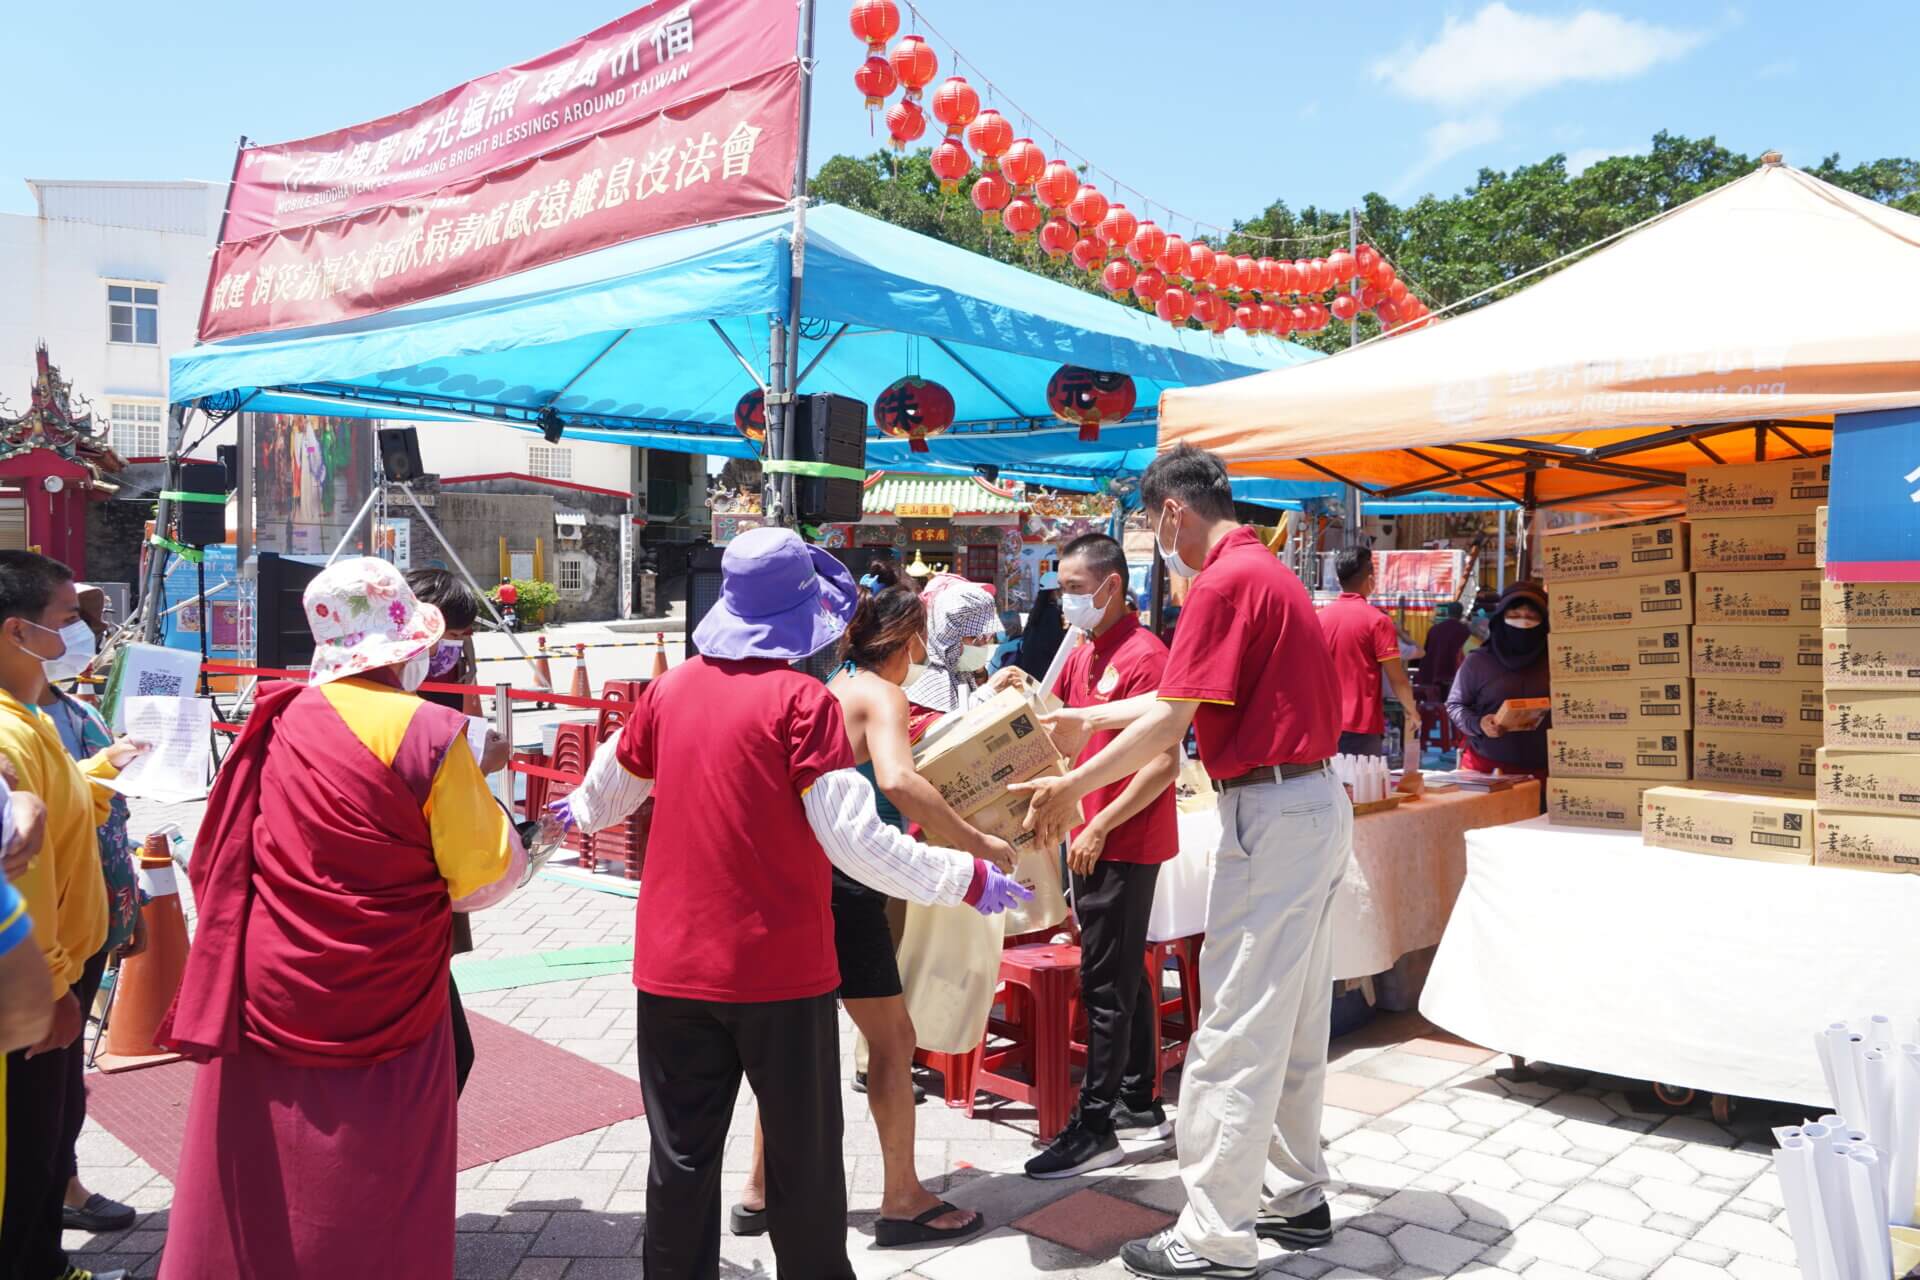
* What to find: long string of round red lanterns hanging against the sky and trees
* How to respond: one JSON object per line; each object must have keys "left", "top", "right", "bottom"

{"left": 849, "top": 0, "right": 1432, "bottom": 338}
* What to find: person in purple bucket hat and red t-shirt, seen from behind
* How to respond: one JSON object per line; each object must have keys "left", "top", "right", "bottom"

{"left": 551, "top": 528, "right": 1031, "bottom": 1280}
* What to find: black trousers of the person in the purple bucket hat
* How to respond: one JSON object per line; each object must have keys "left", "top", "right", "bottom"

{"left": 639, "top": 990, "right": 848, "bottom": 1280}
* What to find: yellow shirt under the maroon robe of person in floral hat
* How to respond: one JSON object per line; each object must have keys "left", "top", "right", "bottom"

{"left": 321, "top": 679, "right": 513, "bottom": 902}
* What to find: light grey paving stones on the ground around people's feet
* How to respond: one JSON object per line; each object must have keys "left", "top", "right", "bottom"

{"left": 67, "top": 844, "right": 1873, "bottom": 1280}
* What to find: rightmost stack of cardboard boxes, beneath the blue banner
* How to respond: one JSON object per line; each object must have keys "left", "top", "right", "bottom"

{"left": 1814, "top": 509, "right": 1920, "bottom": 873}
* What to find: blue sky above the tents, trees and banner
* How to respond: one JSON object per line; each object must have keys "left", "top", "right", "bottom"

{"left": 0, "top": 0, "right": 1920, "bottom": 226}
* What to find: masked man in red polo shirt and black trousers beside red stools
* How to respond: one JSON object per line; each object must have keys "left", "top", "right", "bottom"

{"left": 1027, "top": 533, "right": 1181, "bottom": 1178}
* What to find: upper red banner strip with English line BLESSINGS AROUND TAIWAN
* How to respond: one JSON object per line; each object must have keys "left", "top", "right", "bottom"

{"left": 221, "top": 0, "right": 799, "bottom": 240}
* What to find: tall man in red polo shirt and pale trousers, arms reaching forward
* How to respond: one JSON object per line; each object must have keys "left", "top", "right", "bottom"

{"left": 1021, "top": 445, "right": 1354, "bottom": 1280}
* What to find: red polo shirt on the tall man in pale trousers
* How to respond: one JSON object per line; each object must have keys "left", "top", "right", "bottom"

{"left": 1160, "top": 528, "right": 1340, "bottom": 777}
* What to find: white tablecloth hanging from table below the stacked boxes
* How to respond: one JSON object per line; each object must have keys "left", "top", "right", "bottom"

{"left": 1421, "top": 818, "right": 1920, "bottom": 1105}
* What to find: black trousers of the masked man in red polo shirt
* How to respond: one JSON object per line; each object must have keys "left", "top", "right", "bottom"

{"left": 1073, "top": 862, "right": 1160, "bottom": 1132}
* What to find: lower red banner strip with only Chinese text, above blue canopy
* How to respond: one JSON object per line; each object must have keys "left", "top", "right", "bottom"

{"left": 200, "top": 59, "right": 801, "bottom": 342}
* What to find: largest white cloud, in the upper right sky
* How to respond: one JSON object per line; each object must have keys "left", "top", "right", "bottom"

{"left": 1373, "top": 0, "right": 1707, "bottom": 111}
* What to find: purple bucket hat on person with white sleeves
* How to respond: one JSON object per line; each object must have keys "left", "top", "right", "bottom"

{"left": 693, "top": 530, "right": 860, "bottom": 662}
